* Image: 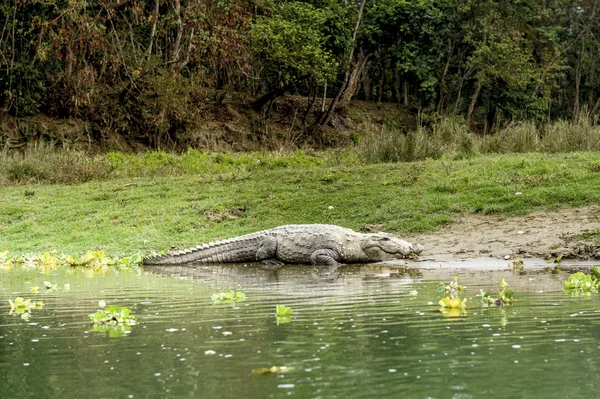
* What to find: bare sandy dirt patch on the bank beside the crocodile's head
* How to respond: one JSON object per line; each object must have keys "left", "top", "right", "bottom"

{"left": 410, "top": 206, "right": 600, "bottom": 260}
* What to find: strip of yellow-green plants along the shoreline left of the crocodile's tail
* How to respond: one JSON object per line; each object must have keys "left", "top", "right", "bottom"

{"left": 0, "top": 251, "right": 142, "bottom": 274}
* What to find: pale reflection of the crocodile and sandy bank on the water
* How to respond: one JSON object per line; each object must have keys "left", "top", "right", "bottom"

{"left": 145, "top": 263, "right": 568, "bottom": 295}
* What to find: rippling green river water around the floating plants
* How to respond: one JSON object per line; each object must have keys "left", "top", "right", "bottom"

{"left": 0, "top": 267, "right": 600, "bottom": 399}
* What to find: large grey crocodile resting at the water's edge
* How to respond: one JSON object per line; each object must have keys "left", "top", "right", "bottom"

{"left": 143, "top": 224, "right": 423, "bottom": 266}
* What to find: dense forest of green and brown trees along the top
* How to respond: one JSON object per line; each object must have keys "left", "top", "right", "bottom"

{"left": 0, "top": 0, "right": 600, "bottom": 147}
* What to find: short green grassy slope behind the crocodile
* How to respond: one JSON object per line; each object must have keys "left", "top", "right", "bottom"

{"left": 0, "top": 153, "right": 600, "bottom": 255}
